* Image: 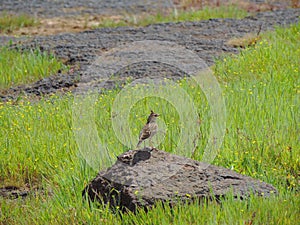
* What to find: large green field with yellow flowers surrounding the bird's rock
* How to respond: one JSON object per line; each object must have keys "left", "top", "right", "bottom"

{"left": 0, "top": 21, "right": 300, "bottom": 224}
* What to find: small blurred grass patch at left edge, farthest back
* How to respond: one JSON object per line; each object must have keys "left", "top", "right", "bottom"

{"left": 0, "top": 12, "right": 37, "bottom": 33}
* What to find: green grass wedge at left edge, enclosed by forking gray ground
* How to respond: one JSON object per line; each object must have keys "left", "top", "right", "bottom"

{"left": 0, "top": 47, "right": 65, "bottom": 89}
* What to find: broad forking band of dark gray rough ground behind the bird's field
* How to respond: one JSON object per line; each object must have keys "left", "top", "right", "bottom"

{"left": 0, "top": 0, "right": 300, "bottom": 101}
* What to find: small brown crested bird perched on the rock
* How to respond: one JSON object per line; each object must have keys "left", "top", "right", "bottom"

{"left": 136, "top": 110, "right": 159, "bottom": 148}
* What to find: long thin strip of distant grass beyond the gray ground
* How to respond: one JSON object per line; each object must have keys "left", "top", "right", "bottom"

{"left": 97, "top": 5, "right": 248, "bottom": 27}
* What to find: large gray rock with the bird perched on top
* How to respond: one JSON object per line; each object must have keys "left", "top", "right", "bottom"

{"left": 83, "top": 148, "right": 277, "bottom": 211}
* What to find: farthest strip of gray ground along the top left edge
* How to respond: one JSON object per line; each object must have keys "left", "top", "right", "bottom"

{"left": 0, "top": 0, "right": 173, "bottom": 17}
